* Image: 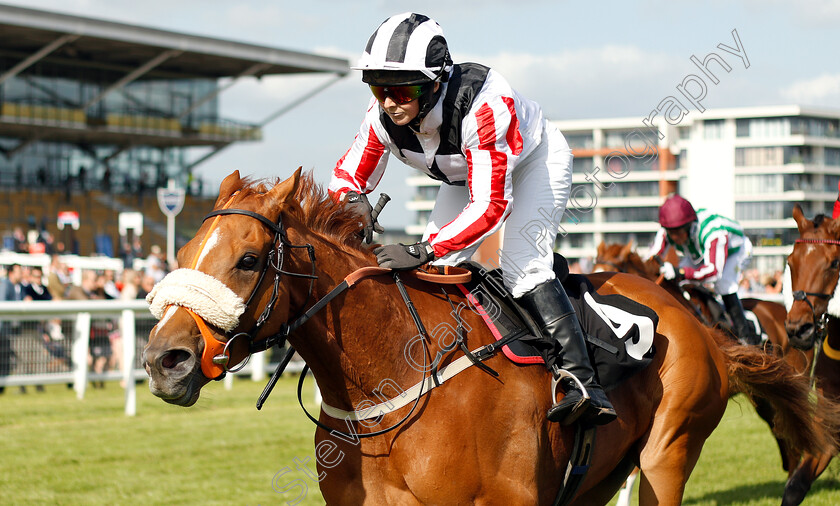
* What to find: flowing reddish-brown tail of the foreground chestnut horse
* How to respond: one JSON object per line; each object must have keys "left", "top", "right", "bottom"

{"left": 712, "top": 330, "right": 840, "bottom": 454}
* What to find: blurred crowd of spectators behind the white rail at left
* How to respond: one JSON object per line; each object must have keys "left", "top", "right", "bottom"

{"left": 0, "top": 243, "right": 171, "bottom": 393}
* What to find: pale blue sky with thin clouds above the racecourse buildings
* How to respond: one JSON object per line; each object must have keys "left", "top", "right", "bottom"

{"left": 0, "top": 0, "right": 840, "bottom": 227}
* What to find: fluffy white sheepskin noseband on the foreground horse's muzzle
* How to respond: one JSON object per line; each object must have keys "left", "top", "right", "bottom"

{"left": 146, "top": 269, "right": 245, "bottom": 332}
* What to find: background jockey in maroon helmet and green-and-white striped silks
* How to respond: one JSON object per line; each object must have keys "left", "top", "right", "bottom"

{"left": 648, "top": 195, "right": 760, "bottom": 344}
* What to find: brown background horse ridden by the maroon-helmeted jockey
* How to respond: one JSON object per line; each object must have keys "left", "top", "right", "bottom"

{"left": 593, "top": 241, "right": 813, "bottom": 475}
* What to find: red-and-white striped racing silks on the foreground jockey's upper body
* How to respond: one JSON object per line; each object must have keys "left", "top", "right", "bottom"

{"left": 329, "top": 70, "right": 544, "bottom": 258}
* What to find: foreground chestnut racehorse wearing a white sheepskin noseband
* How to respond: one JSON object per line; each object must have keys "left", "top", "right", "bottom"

{"left": 144, "top": 170, "right": 840, "bottom": 505}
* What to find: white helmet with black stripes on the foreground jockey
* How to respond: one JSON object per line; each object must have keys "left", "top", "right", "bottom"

{"left": 353, "top": 12, "right": 452, "bottom": 85}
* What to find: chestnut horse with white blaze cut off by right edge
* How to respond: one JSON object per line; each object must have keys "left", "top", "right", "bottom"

{"left": 783, "top": 204, "right": 840, "bottom": 505}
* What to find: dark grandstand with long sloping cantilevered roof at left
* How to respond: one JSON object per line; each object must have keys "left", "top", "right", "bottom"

{"left": 0, "top": 5, "right": 349, "bottom": 255}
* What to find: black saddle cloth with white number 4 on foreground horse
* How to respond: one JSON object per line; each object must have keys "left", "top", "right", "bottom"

{"left": 459, "top": 254, "right": 659, "bottom": 391}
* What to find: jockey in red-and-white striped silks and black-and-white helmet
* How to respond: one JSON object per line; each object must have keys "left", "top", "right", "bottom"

{"left": 329, "top": 13, "right": 616, "bottom": 424}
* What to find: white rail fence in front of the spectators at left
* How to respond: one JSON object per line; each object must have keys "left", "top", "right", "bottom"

{"left": 0, "top": 300, "right": 303, "bottom": 416}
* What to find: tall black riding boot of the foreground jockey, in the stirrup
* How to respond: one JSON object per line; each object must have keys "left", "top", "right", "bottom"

{"left": 516, "top": 279, "right": 616, "bottom": 425}
